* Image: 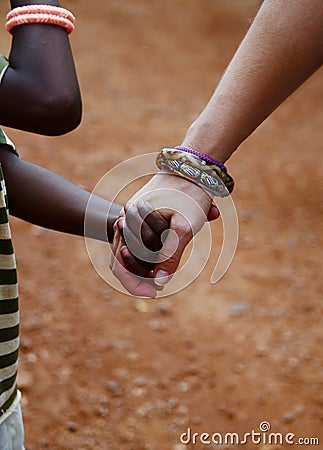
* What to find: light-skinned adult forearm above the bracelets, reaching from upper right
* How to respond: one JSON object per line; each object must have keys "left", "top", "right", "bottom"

{"left": 182, "top": 0, "right": 323, "bottom": 161}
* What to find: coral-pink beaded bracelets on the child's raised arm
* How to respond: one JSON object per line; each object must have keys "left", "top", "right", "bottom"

{"left": 6, "top": 5, "right": 75, "bottom": 34}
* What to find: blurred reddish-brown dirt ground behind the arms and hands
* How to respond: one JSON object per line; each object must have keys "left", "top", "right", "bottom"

{"left": 0, "top": 0, "right": 323, "bottom": 450}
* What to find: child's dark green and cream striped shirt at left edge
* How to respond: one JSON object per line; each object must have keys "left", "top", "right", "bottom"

{"left": 0, "top": 56, "right": 19, "bottom": 423}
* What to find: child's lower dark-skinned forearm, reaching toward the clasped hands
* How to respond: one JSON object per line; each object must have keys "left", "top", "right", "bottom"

{"left": 1, "top": 150, "right": 121, "bottom": 242}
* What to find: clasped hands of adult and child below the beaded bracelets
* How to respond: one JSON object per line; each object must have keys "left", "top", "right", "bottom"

{"left": 111, "top": 172, "right": 219, "bottom": 297}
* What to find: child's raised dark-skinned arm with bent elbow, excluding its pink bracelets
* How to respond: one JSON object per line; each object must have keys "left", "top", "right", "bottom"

{"left": 0, "top": 0, "right": 82, "bottom": 135}
